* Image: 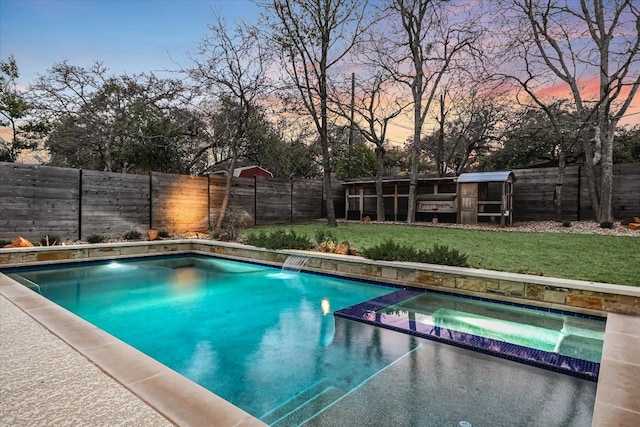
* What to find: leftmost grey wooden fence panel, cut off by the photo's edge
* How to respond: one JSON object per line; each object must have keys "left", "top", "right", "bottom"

{"left": 0, "top": 163, "right": 79, "bottom": 242}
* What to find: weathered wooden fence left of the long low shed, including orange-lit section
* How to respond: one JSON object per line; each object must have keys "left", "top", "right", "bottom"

{"left": 0, "top": 162, "right": 328, "bottom": 240}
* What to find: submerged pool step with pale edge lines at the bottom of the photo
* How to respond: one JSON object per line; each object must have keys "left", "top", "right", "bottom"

{"left": 260, "top": 380, "right": 345, "bottom": 426}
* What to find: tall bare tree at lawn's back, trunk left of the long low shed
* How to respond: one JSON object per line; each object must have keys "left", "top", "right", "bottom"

{"left": 262, "top": 0, "right": 367, "bottom": 226}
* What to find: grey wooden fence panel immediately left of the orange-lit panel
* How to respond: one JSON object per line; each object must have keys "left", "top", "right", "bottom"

{"left": 81, "top": 170, "right": 150, "bottom": 239}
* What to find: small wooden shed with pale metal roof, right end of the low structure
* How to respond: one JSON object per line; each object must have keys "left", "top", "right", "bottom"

{"left": 457, "top": 171, "right": 516, "bottom": 226}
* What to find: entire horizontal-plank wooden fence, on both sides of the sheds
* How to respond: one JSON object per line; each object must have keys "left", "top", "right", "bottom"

{"left": 0, "top": 162, "right": 640, "bottom": 240}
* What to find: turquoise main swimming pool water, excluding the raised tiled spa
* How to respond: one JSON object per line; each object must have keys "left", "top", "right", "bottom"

{"left": 3, "top": 257, "right": 595, "bottom": 425}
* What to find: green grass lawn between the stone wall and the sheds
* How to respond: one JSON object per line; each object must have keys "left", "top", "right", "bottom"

{"left": 243, "top": 221, "right": 640, "bottom": 286}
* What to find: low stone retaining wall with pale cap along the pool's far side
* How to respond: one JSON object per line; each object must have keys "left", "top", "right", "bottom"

{"left": 0, "top": 240, "right": 640, "bottom": 315}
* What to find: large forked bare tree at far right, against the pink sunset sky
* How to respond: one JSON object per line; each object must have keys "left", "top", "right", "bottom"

{"left": 503, "top": 0, "right": 640, "bottom": 222}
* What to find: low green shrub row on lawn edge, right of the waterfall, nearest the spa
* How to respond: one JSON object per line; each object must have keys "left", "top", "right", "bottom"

{"left": 360, "top": 240, "right": 469, "bottom": 267}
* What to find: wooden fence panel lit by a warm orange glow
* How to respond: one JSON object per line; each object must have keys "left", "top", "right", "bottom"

{"left": 151, "top": 172, "right": 209, "bottom": 232}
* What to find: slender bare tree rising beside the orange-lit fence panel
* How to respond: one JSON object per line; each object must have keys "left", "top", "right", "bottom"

{"left": 189, "top": 17, "right": 272, "bottom": 231}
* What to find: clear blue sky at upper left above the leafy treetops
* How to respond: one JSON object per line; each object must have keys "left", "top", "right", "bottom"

{"left": 0, "top": 0, "right": 260, "bottom": 86}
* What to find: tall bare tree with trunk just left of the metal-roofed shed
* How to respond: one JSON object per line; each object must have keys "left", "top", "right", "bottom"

{"left": 371, "top": 0, "right": 477, "bottom": 224}
